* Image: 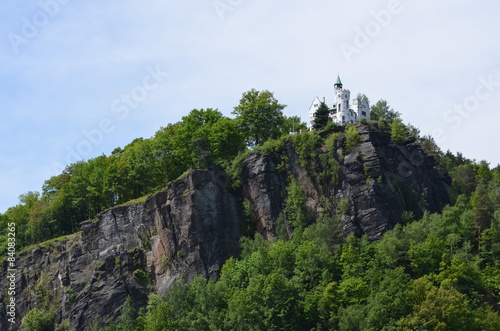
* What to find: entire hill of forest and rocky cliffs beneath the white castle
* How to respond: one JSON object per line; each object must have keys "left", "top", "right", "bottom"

{"left": 0, "top": 91, "right": 500, "bottom": 330}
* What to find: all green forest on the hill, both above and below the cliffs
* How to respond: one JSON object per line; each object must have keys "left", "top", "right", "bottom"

{"left": 0, "top": 90, "right": 500, "bottom": 331}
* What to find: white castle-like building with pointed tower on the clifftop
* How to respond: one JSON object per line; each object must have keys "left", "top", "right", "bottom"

{"left": 309, "top": 76, "right": 370, "bottom": 127}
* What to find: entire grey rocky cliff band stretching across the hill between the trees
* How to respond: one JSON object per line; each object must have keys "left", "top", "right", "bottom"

{"left": 0, "top": 124, "right": 449, "bottom": 330}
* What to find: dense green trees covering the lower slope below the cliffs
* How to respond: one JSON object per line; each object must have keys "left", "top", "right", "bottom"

{"left": 111, "top": 150, "right": 500, "bottom": 331}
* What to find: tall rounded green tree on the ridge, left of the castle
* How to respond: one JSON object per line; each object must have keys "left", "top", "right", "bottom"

{"left": 232, "top": 89, "right": 286, "bottom": 146}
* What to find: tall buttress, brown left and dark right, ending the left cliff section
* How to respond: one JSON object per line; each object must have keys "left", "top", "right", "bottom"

{"left": 146, "top": 168, "right": 241, "bottom": 293}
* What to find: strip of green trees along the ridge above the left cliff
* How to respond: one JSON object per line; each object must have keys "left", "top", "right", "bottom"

{"left": 0, "top": 89, "right": 305, "bottom": 252}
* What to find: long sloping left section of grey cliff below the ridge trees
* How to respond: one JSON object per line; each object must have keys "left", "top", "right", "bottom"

{"left": 0, "top": 167, "right": 241, "bottom": 330}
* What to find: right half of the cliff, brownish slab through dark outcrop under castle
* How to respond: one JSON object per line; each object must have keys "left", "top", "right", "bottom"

{"left": 241, "top": 124, "right": 450, "bottom": 240}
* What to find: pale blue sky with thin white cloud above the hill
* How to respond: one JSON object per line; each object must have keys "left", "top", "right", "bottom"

{"left": 0, "top": 0, "right": 500, "bottom": 213}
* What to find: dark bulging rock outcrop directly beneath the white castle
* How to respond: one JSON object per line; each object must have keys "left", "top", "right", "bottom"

{"left": 336, "top": 125, "right": 451, "bottom": 240}
